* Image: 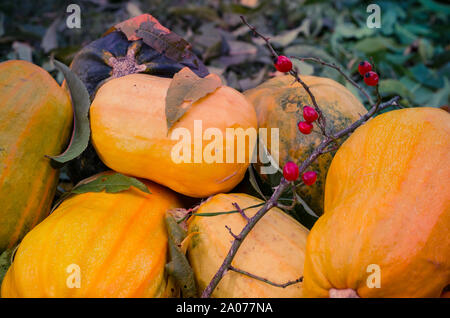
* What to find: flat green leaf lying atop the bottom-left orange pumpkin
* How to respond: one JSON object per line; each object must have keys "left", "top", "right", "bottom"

{"left": 70, "top": 173, "right": 150, "bottom": 194}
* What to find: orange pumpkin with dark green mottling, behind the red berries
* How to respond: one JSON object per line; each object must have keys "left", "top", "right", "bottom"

{"left": 244, "top": 75, "right": 367, "bottom": 214}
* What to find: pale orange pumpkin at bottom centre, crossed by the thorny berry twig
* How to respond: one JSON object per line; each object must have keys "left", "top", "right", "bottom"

{"left": 188, "top": 193, "right": 308, "bottom": 298}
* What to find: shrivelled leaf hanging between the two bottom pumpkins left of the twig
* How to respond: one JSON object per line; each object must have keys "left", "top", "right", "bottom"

{"left": 165, "top": 212, "right": 198, "bottom": 298}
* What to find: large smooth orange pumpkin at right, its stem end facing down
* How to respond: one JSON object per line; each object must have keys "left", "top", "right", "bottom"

{"left": 304, "top": 107, "right": 450, "bottom": 297}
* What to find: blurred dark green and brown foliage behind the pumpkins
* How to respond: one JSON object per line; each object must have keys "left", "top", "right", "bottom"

{"left": 0, "top": 0, "right": 450, "bottom": 107}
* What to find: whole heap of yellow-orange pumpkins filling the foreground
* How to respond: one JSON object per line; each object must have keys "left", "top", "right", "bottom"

{"left": 0, "top": 21, "right": 450, "bottom": 298}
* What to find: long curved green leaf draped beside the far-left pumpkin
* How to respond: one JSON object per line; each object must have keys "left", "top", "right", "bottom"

{"left": 48, "top": 60, "right": 91, "bottom": 163}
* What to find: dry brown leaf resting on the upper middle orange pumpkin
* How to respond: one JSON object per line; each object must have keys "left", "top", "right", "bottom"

{"left": 166, "top": 67, "right": 222, "bottom": 131}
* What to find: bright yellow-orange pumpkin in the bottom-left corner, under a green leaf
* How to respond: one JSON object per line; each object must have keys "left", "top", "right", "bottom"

{"left": 1, "top": 173, "right": 180, "bottom": 298}
